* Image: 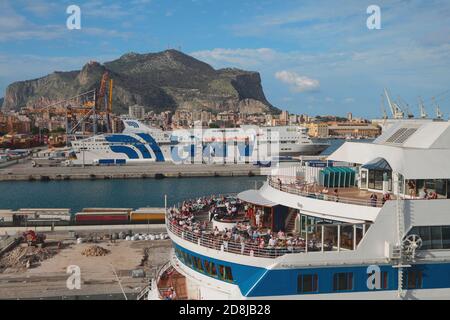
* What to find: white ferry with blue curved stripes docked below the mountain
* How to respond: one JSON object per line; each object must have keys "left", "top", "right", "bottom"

{"left": 71, "top": 119, "right": 329, "bottom": 165}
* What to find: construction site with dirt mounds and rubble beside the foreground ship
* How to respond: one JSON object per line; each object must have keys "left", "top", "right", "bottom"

{"left": 0, "top": 225, "right": 171, "bottom": 300}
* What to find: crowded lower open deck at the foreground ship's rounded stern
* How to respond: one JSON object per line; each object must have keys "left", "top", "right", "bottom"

{"left": 166, "top": 192, "right": 371, "bottom": 258}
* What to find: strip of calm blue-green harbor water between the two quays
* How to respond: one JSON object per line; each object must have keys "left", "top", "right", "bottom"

{"left": 0, "top": 177, "right": 265, "bottom": 212}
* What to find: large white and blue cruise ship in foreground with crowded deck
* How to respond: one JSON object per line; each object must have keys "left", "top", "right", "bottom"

{"left": 146, "top": 121, "right": 450, "bottom": 300}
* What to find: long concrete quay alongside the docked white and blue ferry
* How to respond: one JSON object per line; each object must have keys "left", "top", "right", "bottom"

{"left": 0, "top": 162, "right": 265, "bottom": 181}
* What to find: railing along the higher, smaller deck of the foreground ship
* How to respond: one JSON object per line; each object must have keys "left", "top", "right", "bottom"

{"left": 267, "top": 177, "right": 383, "bottom": 208}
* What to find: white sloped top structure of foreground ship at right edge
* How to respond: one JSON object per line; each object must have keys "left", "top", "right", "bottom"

{"left": 328, "top": 120, "right": 450, "bottom": 179}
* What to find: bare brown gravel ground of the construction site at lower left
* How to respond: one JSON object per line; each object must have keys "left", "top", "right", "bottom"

{"left": 0, "top": 240, "right": 172, "bottom": 299}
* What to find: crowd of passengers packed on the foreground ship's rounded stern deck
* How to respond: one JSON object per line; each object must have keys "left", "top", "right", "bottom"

{"left": 169, "top": 196, "right": 333, "bottom": 254}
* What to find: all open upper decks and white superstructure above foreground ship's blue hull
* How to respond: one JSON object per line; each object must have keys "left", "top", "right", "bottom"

{"left": 167, "top": 122, "right": 450, "bottom": 258}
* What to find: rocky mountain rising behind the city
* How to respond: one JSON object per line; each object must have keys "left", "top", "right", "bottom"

{"left": 2, "top": 50, "right": 279, "bottom": 113}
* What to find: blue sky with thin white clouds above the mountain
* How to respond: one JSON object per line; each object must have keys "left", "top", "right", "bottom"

{"left": 0, "top": 0, "right": 450, "bottom": 117}
